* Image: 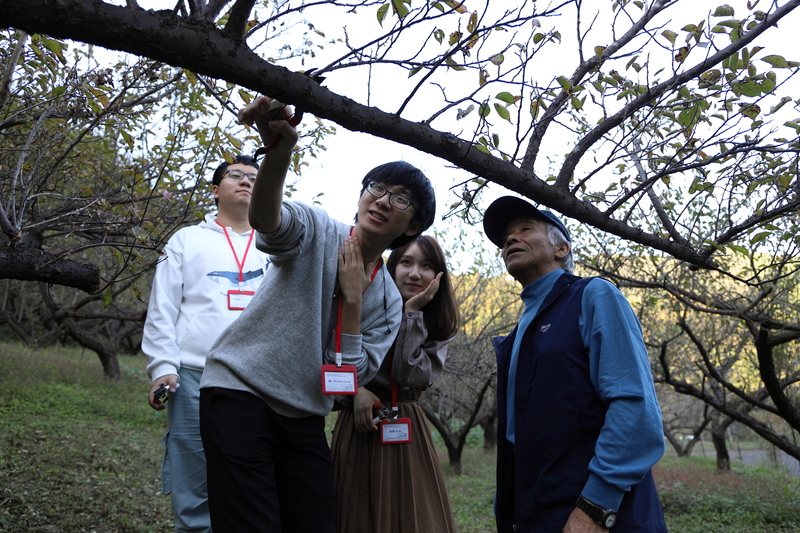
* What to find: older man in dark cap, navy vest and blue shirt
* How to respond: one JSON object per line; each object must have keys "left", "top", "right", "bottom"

{"left": 483, "top": 196, "right": 667, "bottom": 533}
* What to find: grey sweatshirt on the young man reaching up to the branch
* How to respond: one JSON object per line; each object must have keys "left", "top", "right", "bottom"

{"left": 200, "top": 202, "right": 402, "bottom": 418}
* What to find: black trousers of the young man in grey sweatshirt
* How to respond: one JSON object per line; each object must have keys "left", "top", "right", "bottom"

{"left": 200, "top": 388, "right": 334, "bottom": 533}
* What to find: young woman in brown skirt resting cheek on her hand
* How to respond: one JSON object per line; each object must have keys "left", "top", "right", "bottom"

{"left": 332, "top": 235, "right": 458, "bottom": 533}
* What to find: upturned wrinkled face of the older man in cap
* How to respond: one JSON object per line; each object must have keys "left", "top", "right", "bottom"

{"left": 503, "top": 216, "right": 569, "bottom": 286}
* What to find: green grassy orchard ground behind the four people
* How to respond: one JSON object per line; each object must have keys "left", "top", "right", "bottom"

{"left": 0, "top": 343, "right": 800, "bottom": 533}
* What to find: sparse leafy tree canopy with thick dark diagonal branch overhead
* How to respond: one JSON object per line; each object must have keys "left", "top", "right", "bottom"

{"left": 0, "top": 0, "right": 800, "bottom": 282}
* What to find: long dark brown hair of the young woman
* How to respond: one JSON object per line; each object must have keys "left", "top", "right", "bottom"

{"left": 386, "top": 235, "right": 459, "bottom": 341}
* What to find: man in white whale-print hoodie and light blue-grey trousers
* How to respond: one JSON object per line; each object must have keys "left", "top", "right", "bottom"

{"left": 142, "top": 156, "right": 268, "bottom": 532}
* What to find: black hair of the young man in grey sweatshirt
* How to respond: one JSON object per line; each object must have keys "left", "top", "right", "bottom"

{"left": 356, "top": 161, "right": 436, "bottom": 250}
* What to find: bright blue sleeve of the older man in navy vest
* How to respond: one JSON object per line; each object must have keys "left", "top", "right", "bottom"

{"left": 580, "top": 278, "right": 664, "bottom": 509}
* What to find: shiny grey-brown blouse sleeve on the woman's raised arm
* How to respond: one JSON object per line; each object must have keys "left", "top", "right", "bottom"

{"left": 392, "top": 311, "right": 453, "bottom": 389}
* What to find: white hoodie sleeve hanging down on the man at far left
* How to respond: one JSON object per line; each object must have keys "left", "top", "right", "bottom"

{"left": 142, "top": 232, "right": 183, "bottom": 380}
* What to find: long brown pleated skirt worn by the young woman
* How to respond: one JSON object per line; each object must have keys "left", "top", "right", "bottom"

{"left": 331, "top": 401, "right": 455, "bottom": 533}
